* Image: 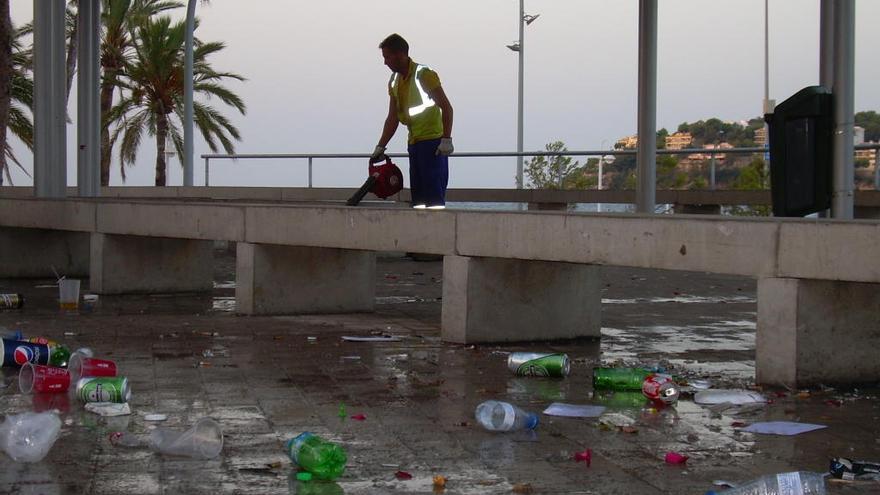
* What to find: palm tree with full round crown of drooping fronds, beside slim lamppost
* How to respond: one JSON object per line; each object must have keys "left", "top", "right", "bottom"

{"left": 108, "top": 16, "right": 245, "bottom": 186}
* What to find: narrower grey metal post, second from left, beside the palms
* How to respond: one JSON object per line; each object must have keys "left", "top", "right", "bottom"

{"left": 76, "top": 0, "right": 101, "bottom": 197}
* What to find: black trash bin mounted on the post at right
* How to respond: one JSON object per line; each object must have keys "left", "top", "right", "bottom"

{"left": 764, "top": 86, "right": 834, "bottom": 217}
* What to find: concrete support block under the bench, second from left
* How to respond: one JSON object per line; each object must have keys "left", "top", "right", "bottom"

{"left": 89, "top": 233, "right": 214, "bottom": 294}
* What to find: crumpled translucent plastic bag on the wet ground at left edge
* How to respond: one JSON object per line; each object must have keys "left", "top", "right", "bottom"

{"left": 0, "top": 412, "right": 61, "bottom": 462}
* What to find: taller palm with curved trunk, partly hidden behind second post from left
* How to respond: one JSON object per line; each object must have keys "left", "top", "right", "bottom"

{"left": 101, "top": 0, "right": 182, "bottom": 186}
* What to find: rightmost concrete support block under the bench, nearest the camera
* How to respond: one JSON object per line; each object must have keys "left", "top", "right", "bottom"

{"left": 755, "top": 278, "right": 880, "bottom": 387}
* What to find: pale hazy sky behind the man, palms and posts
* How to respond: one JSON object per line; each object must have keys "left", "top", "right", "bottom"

{"left": 11, "top": 0, "right": 880, "bottom": 188}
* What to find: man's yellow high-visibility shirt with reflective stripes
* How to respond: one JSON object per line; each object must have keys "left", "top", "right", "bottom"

{"left": 388, "top": 59, "right": 443, "bottom": 144}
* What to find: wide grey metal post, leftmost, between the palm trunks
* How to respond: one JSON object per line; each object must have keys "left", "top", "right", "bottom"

{"left": 34, "top": 0, "right": 67, "bottom": 198}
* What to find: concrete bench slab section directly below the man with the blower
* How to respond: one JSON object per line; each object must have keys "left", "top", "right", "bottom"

{"left": 246, "top": 206, "right": 456, "bottom": 254}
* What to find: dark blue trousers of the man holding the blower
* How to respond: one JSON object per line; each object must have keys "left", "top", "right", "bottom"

{"left": 407, "top": 139, "right": 449, "bottom": 206}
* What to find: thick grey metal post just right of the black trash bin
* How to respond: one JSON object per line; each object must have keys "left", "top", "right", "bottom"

{"left": 831, "top": 0, "right": 856, "bottom": 219}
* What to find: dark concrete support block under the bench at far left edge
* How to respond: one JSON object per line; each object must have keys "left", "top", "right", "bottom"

{"left": 0, "top": 227, "right": 89, "bottom": 278}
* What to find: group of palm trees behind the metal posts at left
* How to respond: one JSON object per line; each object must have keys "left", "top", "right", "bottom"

{"left": 0, "top": 0, "right": 246, "bottom": 186}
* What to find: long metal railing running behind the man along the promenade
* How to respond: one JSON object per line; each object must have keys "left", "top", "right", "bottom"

{"left": 201, "top": 143, "right": 880, "bottom": 190}
